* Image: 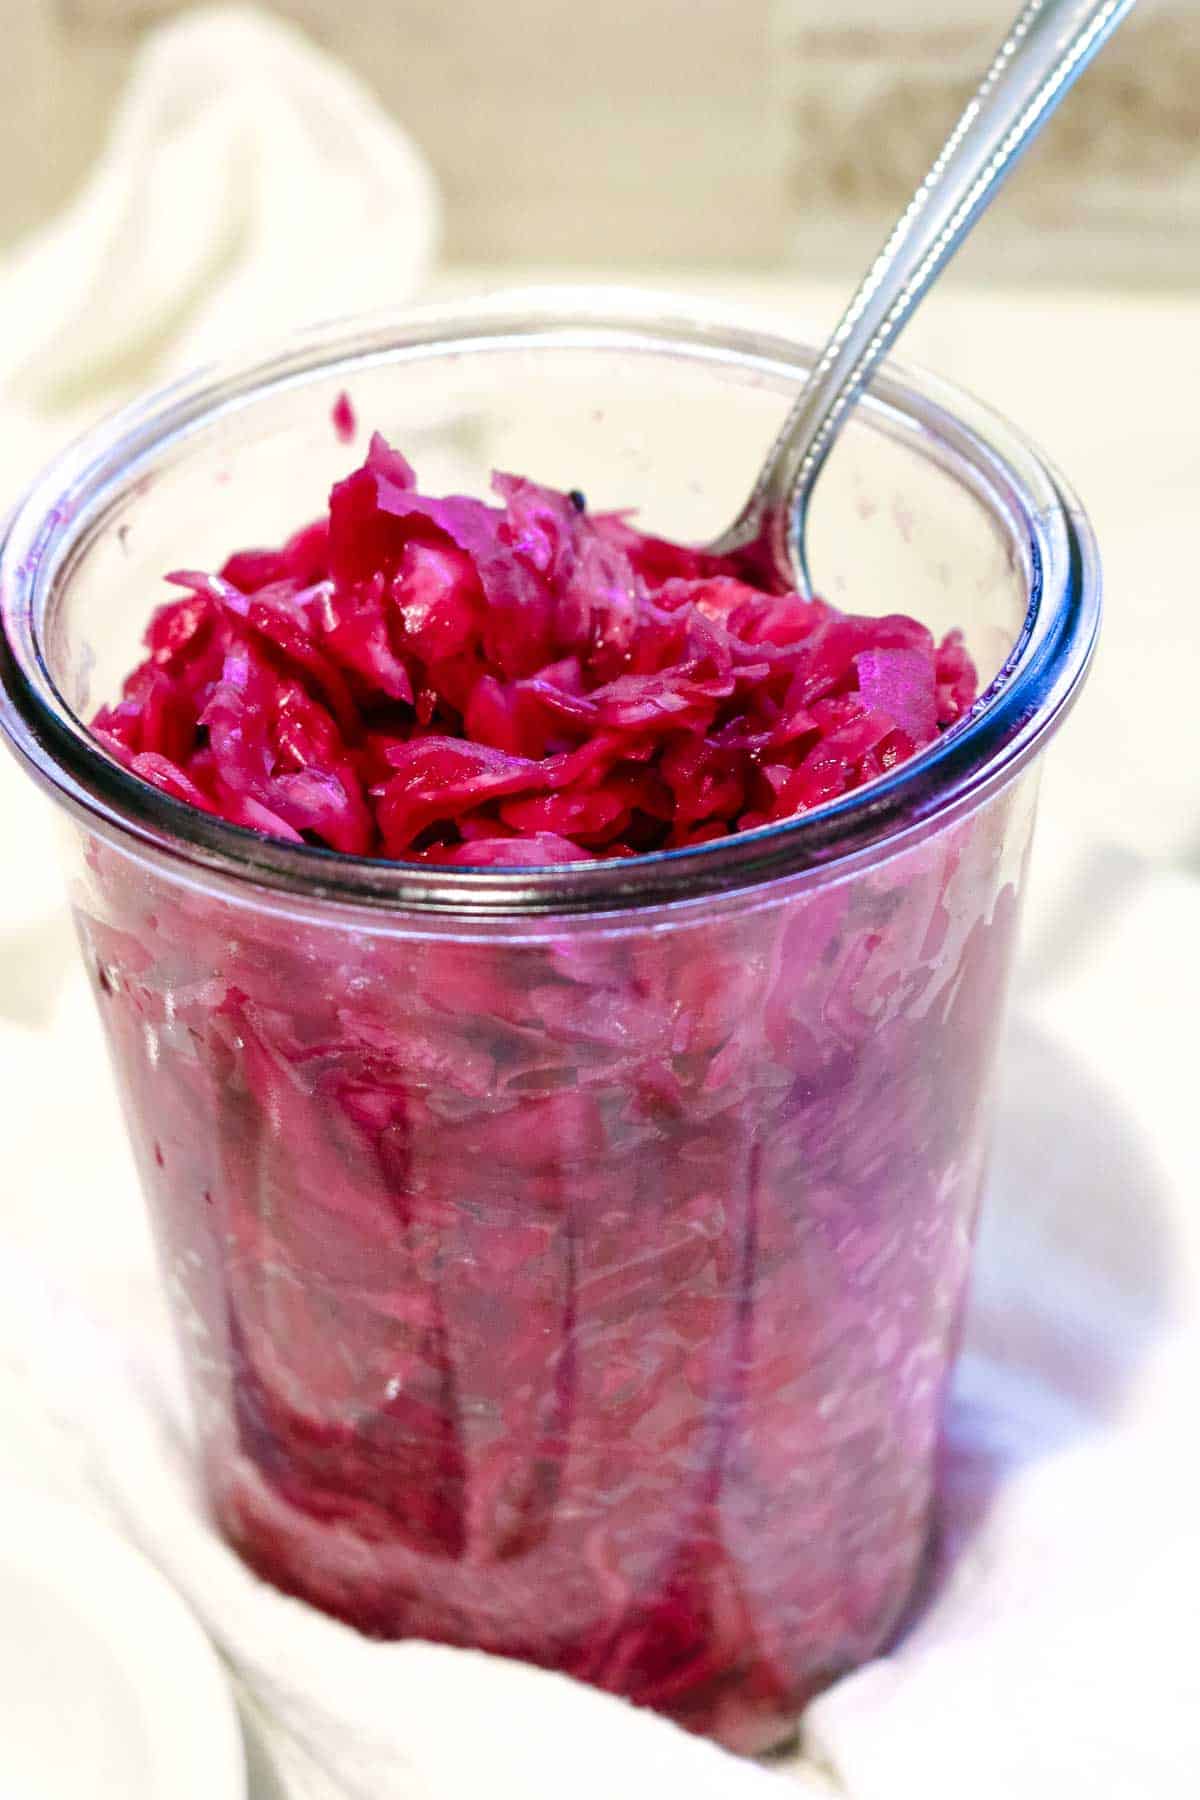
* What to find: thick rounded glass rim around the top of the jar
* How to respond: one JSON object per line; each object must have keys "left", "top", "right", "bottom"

{"left": 0, "top": 288, "right": 1101, "bottom": 918}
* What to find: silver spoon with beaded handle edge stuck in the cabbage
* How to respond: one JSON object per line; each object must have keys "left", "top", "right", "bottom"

{"left": 711, "top": 0, "right": 1133, "bottom": 596}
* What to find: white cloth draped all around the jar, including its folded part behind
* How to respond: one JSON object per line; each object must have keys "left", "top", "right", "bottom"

{"left": 0, "top": 11, "right": 1200, "bottom": 1800}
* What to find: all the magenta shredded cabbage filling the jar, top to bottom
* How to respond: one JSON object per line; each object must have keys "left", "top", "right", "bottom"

{"left": 77, "top": 437, "right": 1027, "bottom": 1750}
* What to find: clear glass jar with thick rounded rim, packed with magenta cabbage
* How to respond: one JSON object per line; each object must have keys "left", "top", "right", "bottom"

{"left": 0, "top": 295, "right": 1099, "bottom": 1751}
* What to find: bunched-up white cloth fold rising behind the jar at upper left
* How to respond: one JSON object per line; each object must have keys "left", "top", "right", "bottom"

{"left": 0, "top": 7, "right": 439, "bottom": 509}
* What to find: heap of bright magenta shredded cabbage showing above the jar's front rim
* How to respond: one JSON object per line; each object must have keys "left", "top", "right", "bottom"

{"left": 94, "top": 432, "right": 975, "bottom": 864}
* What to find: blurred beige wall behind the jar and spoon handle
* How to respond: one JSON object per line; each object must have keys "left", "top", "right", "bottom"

{"left": 0, "top": 0, "right": 1200, "bottom": 286}
